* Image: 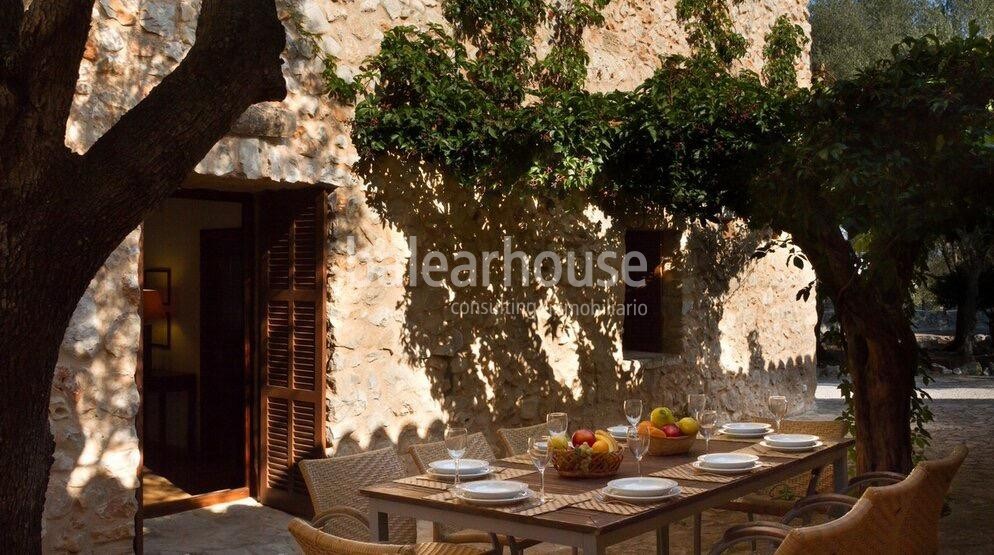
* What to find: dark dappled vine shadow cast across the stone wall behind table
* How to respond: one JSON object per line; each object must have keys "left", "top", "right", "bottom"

{"left": 332, "top": 154, "right": 805, "bottom": 452}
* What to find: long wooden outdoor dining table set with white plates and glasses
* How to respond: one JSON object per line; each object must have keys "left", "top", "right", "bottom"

{"left": 361, "top": 439, "right": 853, "bottom": 554}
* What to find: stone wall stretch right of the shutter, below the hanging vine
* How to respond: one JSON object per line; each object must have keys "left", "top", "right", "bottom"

{"left": 328, "top": 162, "right": 815, "bottom": 452}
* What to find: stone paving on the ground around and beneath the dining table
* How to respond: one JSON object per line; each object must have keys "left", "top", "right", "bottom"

{"left": 145, "top": 376, "right": 994, "bottom": 555}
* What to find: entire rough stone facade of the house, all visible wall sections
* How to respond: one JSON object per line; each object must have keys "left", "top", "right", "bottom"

{"left": 44, "top": 0, "right": 814, "bottom": 552}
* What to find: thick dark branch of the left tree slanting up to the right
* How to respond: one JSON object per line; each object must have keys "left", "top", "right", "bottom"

{"left": 74, "top": 0, "right": 286, "bottom": 250}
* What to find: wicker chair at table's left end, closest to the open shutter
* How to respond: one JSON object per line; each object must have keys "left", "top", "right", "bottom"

{"left": 300, "top": 447, "right": 418, "bottom": 543}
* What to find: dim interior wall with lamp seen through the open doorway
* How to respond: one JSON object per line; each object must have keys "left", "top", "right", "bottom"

{"left": 144, "top": 198, "right": 242, "bottom": 444}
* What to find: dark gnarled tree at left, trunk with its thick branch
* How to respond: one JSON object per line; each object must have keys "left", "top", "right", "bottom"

{"left": 0, "top": 0, "right": 286, "bottom": 553}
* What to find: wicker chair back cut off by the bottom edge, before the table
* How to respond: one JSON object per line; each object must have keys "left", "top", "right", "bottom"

{"left": 288, "top": 518, "right": 484, "bottom": 555}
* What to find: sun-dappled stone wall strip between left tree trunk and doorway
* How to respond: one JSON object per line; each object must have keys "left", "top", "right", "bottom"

{"left": 42, "top": 231, "right": 141, "bottom": 553}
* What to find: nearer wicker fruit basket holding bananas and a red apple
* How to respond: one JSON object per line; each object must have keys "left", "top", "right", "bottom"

{"left": 549, "top": 430, "right": 624, "bottom": 478}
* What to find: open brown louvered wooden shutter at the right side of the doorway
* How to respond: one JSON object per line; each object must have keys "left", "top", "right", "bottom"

{"left": 259, "top": 191, "right": 326, "bottom": 515}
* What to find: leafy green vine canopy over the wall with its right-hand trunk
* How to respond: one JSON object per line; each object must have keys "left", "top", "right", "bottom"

{"left": 332, "top": 0, "right": 994, "bottom": 470}
